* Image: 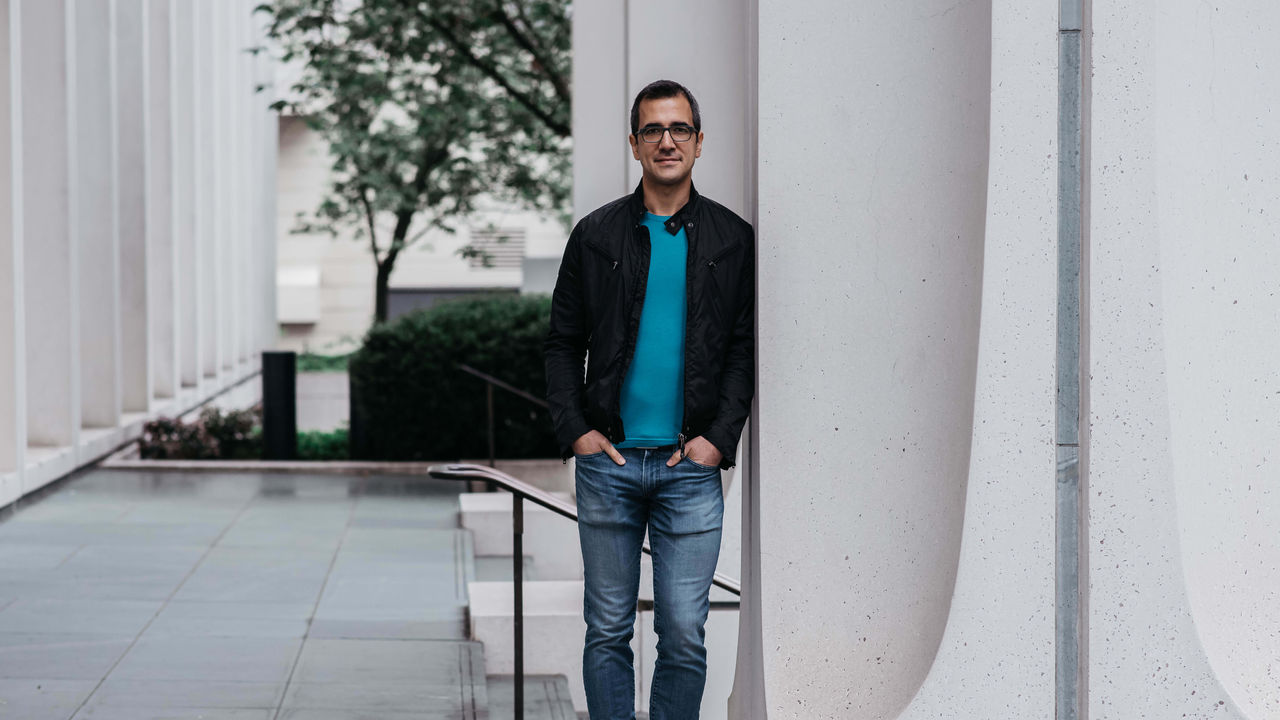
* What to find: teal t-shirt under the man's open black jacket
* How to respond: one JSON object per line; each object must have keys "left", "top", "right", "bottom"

{"left": 618, "top": 213, "right": 689, "bottom": 447}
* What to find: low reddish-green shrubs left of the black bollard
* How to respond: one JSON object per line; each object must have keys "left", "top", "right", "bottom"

{"left": 138, "top": 406, "right": 262, "bottom": 460}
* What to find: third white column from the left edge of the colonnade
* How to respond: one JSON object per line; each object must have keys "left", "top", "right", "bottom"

{"left": 73, "top": 0, "right": 123, "bottom": 428}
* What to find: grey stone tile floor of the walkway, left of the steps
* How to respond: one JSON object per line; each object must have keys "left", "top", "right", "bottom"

{"left": 0, "top": 470, "right": 485, "bottom": 720}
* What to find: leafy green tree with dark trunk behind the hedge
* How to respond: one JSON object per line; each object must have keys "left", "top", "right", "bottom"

{"left": 257, "top": 0, "right": 570, "bottom": 323}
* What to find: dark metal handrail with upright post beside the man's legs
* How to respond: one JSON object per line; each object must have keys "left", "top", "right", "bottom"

{"left": 426, "top": 458, "right": 742, "bottom": 720}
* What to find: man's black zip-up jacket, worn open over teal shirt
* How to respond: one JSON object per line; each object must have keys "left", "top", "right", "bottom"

{"left": 544, "top": 181, "right": 755, "bottom": 469}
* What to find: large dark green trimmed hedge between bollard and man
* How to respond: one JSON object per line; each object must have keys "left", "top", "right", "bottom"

{"left": 349, "top": 295, "right": 557, "bottom": 460}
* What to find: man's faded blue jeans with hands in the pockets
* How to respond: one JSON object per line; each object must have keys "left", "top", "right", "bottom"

{"left": 576, "top": 448, "right": 724, "bottom": 720}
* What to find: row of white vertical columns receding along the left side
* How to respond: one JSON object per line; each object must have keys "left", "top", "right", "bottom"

{"left": 0, "top": 0, "right": 276, "bottom": 506}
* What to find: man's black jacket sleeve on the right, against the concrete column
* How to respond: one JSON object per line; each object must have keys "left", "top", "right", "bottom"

{"left": 703, "top": 225, "right": 755, "bottom": 470}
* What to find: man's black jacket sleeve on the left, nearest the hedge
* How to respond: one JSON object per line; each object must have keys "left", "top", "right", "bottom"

{"left": 543, "top": 223, "right": 591, "bottom": 457}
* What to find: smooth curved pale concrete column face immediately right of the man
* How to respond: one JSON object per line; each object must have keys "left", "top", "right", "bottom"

{"left": 756, "top": 0, "right": 988, "bottom": 717}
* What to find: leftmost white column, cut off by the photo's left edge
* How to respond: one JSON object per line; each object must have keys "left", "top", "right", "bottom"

{"left": 0, "top": 0, "right": 27, "bottom": 497}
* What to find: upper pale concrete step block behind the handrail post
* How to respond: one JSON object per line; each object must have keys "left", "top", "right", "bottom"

{"left": 458, "top": 492, "right": 582, "bottom": 580}
